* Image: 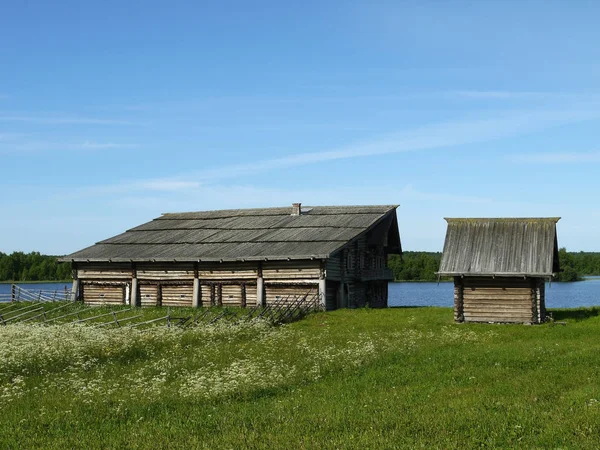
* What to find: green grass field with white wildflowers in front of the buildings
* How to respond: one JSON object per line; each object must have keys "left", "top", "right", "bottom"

{"left": 0, "top": 308, "right": 600, "bottom": 449}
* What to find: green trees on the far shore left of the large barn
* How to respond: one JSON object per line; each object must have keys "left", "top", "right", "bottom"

{"left": 0, "top": 252, "right": 72, "bottom": 281}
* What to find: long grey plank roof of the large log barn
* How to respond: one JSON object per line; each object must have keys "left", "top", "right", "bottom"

{"left": 61, "top": 205, "right": 400, "bottom": 262}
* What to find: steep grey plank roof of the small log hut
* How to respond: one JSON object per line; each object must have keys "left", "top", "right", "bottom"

{"left": 439, "top": 217, "right": 560, "bottom": 277}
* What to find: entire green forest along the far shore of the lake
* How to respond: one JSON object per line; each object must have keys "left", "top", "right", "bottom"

{"left": 0, "top": 248, "right": 600, "bottom": 281}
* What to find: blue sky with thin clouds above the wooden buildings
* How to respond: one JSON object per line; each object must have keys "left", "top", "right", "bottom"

{"left": 0, "top": 1, "right": 600, "bottom": 254}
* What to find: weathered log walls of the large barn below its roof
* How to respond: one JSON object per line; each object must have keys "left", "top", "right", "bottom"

{"left": 76, "top": 251, "right": 387, "bottom": 310}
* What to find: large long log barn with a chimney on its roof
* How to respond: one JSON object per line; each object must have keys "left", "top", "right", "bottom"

{"left": 61, "top": 203, "right": 401, "bottom": 309}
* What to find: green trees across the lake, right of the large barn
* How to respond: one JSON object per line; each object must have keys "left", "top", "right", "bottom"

{"left": 388, "top": 248, "right": 600, "bottom": 281}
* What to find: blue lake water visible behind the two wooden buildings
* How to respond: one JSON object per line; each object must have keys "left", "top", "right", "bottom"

{"left": 0, "top": 277, "right": 600, "bottom": 308}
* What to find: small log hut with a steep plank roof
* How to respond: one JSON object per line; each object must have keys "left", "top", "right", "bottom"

{"left": 439, "top": 217, "right": 559, "bottom": 323}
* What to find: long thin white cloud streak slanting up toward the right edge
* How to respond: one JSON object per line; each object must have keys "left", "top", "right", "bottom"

{"left": 65, "top": 110, "right": 600, "bottom": 197}
